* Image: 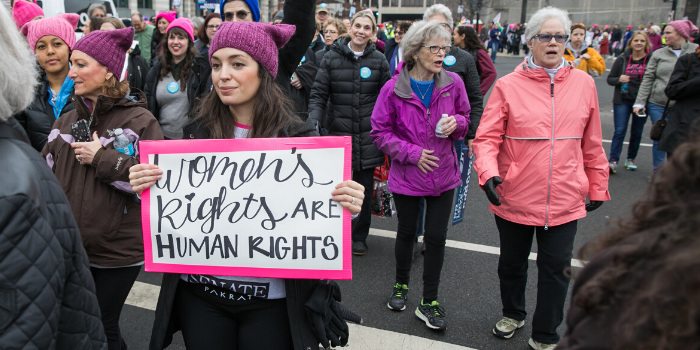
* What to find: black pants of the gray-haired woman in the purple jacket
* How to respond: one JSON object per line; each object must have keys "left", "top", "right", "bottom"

{"left": 394, "top": 190, "right": 455, "bottom": 302}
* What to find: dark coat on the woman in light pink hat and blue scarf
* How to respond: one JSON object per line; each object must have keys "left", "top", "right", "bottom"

{"left": 15, "top": 75, "right": 75, "bottom": 152}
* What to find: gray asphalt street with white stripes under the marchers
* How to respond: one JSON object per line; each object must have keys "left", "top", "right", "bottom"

{"left": 121, "top": 56, "right": 652, "bottom": 350}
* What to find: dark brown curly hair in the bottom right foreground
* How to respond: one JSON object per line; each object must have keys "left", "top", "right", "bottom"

{"left": 573, "top": 121, "right": 700, "bottom": 350}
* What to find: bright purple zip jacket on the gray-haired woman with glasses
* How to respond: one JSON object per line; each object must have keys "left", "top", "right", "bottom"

{"left": 370, "top": 62, "right": 471, "bottom": 196}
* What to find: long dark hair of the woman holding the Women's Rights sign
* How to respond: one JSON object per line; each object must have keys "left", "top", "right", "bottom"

{"left": 192, "top": 64, "right": 301, "bottom": 139}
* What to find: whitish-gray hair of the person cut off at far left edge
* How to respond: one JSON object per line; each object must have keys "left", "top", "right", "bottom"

{"left": 0, "top": 6, "right": 38, "bottom": 121}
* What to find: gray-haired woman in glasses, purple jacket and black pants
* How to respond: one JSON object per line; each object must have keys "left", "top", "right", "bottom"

{"left": 370, "top": 21, "right": 471, "bottom": 330}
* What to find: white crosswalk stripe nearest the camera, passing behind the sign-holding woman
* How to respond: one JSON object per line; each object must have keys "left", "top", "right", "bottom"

{"left": 126, "top": 281, "right": 477, "bottom": 350}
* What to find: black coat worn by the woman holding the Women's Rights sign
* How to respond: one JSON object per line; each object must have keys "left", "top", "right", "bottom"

{"left": 149, "top": 119, "right": 319, "bottom": 350}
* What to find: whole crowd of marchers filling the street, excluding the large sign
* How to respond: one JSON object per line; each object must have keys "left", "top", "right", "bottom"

{"left": 0, "top": 0, "right": 700, "bottom": 350}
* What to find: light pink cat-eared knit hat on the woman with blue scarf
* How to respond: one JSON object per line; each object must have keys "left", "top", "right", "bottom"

{"left": 20, "top": 13, "right": 80, "bottom": 51}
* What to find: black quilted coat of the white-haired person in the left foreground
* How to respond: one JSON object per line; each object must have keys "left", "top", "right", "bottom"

{"left": 0, "top": 118, "right": 107, "bottom": 350}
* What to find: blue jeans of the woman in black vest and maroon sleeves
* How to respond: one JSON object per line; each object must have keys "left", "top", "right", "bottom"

{"left": 610, "top": 99, "right": 647, "bottom": 162}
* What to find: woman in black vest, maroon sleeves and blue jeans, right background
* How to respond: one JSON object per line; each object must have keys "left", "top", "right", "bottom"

{"left": 607, "top": 32, "right": 652, "bottom": 174}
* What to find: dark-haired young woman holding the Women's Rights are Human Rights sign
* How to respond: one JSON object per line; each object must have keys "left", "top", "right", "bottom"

{"left": 130, "top": 22, "right": 364, "bottom": 350}
